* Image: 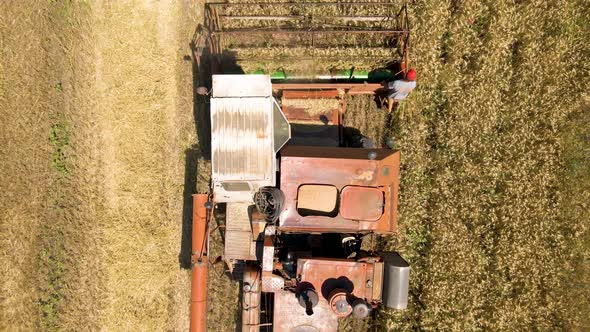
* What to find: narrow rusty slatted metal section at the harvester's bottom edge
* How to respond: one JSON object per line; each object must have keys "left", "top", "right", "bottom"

{"left": 242, "top": 265, "right": 262, "bottom": 332}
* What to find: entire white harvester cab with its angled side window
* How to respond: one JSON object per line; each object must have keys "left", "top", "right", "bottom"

{"left": 211, "top": 75, "right": 291, "bottom": 203}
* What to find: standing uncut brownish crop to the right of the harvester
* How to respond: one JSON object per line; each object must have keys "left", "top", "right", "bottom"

{"left": 376, "top": 1, "right": 589, "bottom": 331}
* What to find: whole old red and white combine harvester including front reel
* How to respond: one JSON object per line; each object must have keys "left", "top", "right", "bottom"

{"left": 191, "top": 2, "right": 409, "bottom": 331}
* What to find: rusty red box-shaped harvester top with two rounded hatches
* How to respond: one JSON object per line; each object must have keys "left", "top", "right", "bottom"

{"left": 278, "top": 146, "right": 399, "bottom": 233}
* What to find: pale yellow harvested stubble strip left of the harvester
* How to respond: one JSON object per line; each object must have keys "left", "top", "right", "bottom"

{"left": 0, "top": 1, "right": 201, "bottom": 331}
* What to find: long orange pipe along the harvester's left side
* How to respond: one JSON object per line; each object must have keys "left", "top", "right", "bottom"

{"left": 190, "top": 194, "right": 209, "bottom": 332}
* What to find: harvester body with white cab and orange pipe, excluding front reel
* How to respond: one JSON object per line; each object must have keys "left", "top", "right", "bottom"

{"left": 191, "top": 75, "right": 409, "bottom": 331}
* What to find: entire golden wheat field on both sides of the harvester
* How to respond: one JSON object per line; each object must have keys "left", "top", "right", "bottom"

{"left": 0, "top": 0, "right": 590, "bottom": 331}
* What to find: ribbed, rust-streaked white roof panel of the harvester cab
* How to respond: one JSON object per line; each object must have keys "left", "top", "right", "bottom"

{"left": 211, "top": 97, "right": 275, "bottom": 181}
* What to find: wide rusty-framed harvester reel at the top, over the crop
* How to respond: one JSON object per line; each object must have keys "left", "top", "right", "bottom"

{"left": 204, "top": 1, "right": 409, "bottom": 74}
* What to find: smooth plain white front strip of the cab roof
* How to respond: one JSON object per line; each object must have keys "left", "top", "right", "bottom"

{"left": 213, "top": 75, "right": 272, "bottom": 98}
